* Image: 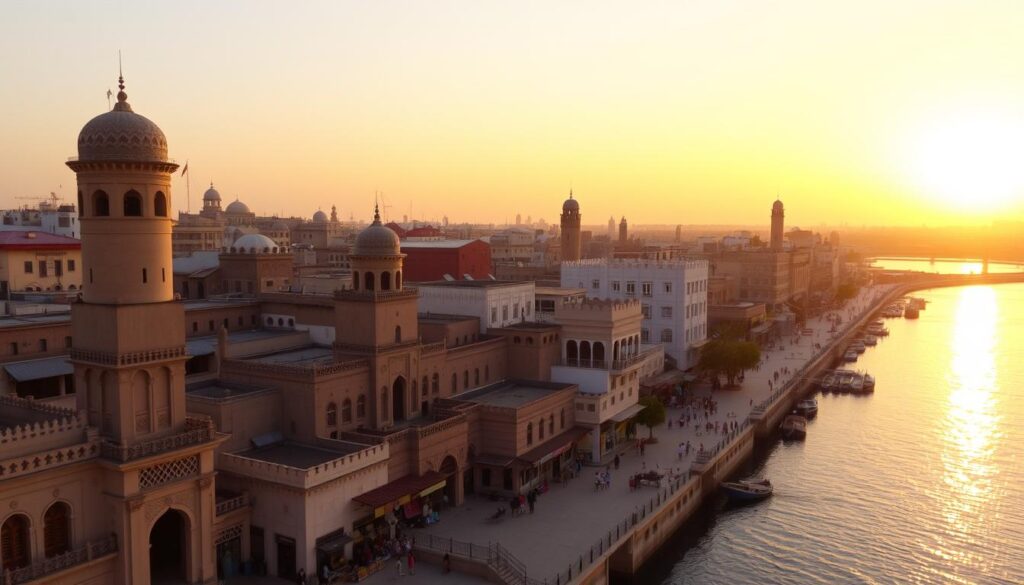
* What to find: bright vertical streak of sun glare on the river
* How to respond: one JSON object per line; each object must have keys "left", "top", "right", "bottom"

{"left": 932, "top": 287, "right": 998, "bottom": 577}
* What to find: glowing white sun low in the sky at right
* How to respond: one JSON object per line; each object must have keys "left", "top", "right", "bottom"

{"left": 908, "top": 113, "right": 1024, "bottom": 211}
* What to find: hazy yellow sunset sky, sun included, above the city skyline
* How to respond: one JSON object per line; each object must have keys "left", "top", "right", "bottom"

{"left": 0, "top": 0, "right": 1024, "bottom": 226}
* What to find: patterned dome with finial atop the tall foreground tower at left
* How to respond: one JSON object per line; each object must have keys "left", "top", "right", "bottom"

{"left": 78, "top": 78, "right": 167, "bottom": 162}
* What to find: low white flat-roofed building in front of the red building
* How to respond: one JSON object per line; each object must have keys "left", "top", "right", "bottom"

{"left": 416, "top": 281, "right": 536, "bottom": 333}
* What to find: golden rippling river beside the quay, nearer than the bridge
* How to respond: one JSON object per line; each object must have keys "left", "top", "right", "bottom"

{"left": 655, "top": 285, "right": 1024, "bottom": 585}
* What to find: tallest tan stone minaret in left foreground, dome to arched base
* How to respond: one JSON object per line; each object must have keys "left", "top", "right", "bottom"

{"left": 67, "top": 72, "right": 223, "bottom": 585}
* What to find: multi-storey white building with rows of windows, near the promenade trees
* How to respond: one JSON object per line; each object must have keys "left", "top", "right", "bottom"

{"left": 561, "top": 258, "right": 708, "bottom": 370}
